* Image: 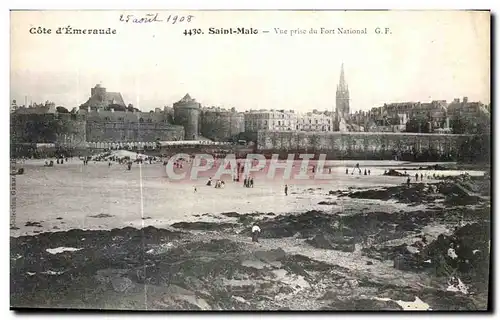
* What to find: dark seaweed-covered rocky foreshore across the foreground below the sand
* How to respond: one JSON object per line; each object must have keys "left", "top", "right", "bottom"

{"left": 10, "top": 178, "right": 491, "bottom": 310}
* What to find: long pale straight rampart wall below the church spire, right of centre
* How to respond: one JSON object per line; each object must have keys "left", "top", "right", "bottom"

{"left": 256, "top": 131, "right": 471, "bottom": 161}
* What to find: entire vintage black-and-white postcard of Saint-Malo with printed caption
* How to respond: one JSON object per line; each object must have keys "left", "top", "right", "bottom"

{"left": 10, "top": 10, "right": 492, "bottom": 311}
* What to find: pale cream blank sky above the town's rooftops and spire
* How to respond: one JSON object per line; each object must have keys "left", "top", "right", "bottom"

{"left": 10, "top": 11, "right": 490, "bottom": 112}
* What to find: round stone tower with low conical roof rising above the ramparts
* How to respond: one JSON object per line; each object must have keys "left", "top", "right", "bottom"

{"left": 174, "top": 93, "right": 200, "bottom": 140}
